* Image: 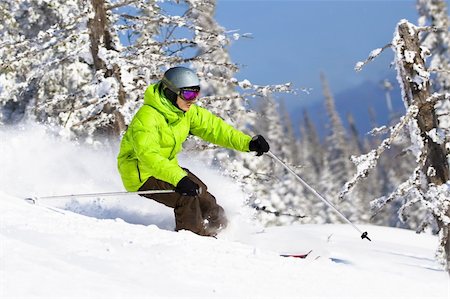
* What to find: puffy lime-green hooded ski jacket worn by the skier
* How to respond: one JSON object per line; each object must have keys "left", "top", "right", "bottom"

{"left": 117, "top": 83, "right": 251, "bottom": 191}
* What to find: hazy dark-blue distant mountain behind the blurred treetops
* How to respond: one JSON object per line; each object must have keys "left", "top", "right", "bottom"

{"left": 292, "top": 78, "right": 404, "bottom": 136}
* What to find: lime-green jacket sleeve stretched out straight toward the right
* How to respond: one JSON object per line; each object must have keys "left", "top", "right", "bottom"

{"left": 189, "top": 105, "right": 252, "bottom": 152}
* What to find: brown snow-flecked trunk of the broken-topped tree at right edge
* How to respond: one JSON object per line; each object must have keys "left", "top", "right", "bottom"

{"left": 397, "top": 22, "right": 450, "bottom": 267}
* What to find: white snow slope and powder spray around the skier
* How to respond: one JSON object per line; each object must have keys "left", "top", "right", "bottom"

{"left": 0, "top": 126, "right": 450, "bottom": 298}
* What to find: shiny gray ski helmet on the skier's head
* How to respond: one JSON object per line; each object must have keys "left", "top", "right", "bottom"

{"left": 161, "top": 66, "right": 200, "bottom": 94}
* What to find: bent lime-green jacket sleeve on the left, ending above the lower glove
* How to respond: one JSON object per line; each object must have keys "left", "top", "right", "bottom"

{"left": 132, "top": 113, "right": 187, "bottom": 186}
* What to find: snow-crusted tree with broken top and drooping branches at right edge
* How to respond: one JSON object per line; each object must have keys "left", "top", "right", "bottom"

{"left": 341, "top": 20, "right": 450, "bottom": 269}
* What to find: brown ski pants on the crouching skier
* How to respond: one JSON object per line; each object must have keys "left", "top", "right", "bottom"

{"left": 139, "top": 169, "right": 227, "bottom": 236}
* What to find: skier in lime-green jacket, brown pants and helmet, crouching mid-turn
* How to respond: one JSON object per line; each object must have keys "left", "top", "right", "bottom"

{"left": 118, "top": 67, "right": 269, "bottom": 236}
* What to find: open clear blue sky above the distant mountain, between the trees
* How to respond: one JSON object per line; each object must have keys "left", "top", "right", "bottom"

{"left": 216, "top": 0, "right": 446, "bottom": 107}
